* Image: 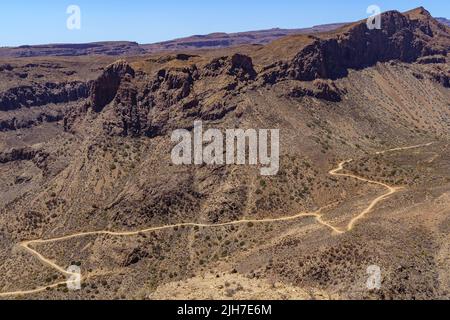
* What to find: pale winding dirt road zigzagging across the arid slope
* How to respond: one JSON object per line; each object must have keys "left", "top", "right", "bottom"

{"left": 0, "top": 143, "right": 433, "bottom": 298}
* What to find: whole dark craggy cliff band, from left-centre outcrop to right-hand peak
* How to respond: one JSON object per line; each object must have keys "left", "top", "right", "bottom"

{"left": 61, "top": 9, "right": 450, "bottom": 137}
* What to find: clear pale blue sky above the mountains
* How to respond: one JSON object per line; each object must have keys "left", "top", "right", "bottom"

{"left": 0, "top": 0, "right": 450, "bottom": 46}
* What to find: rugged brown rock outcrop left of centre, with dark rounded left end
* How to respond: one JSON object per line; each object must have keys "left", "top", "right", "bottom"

{"left": 84, "top": 54, "right": 253, "bottom": 136}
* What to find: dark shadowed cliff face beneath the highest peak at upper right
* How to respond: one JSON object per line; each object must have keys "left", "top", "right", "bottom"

{"left": 265, "top": 9, "right": 450, "bottom": 83}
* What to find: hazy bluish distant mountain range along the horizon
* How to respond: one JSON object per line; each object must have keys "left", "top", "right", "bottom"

{"left": 0, "top": 18, "right": 450, "bottom": 57}
